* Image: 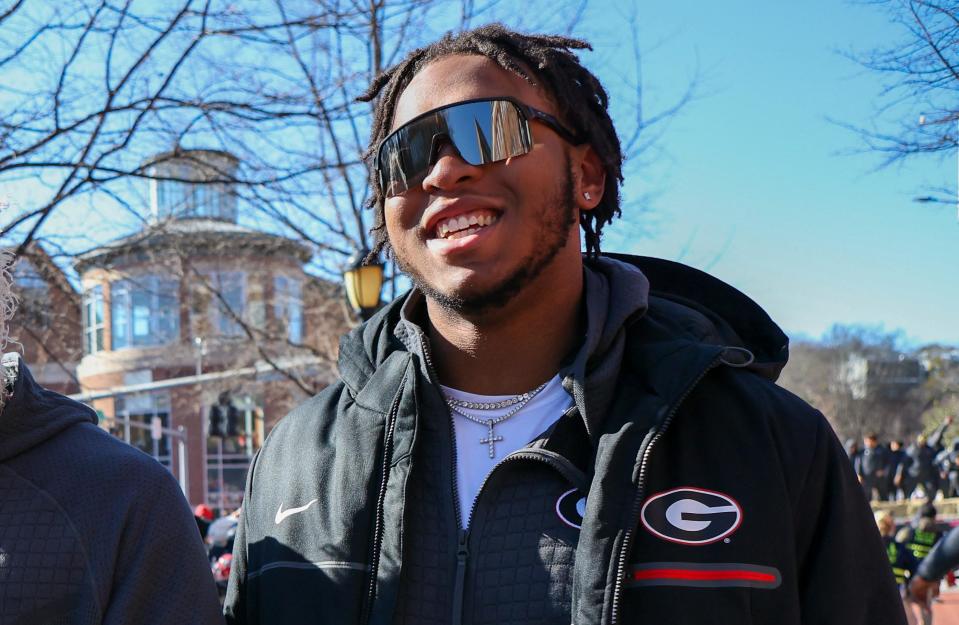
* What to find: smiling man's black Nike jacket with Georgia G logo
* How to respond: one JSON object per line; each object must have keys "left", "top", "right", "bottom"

{"left": 226, "top": 258, "right": 904, "bottom": 625}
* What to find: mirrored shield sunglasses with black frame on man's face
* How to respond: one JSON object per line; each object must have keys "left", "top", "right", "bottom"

{"left": 374, "top": 97, "right": 582, "bottom": 197}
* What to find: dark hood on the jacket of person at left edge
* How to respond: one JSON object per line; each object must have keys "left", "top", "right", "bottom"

{"left": 0, "top": 354, "right": 97, "bottom": 462}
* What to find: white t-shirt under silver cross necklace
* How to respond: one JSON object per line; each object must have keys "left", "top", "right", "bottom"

{"left": 441, "top": 375, "right": 573, "bottom": 529}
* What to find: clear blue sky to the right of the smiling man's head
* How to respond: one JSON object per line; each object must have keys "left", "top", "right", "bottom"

{"left": 583, "top": 0, "right": 959, "bottom": 343}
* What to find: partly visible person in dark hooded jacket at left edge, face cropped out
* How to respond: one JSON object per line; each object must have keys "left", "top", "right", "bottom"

{"left": 0, "top": 354, "right": 222, "bottom": 625}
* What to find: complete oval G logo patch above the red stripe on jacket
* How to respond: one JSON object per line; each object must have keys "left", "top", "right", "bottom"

{"left": 640, "top": 486, "right": 743, "bottom": 545}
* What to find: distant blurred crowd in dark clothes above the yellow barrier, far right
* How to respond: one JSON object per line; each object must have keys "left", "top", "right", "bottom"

{"left": 846, "top": 416, "right": 959, "bottom": 501}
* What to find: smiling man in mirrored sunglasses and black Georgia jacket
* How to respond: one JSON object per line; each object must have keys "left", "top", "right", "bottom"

{"left": 226, "top": 25, "right": 904, "bottom": 625}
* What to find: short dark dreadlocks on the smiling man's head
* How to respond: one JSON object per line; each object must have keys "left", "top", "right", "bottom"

{"left": 357, "top": 24, "right": 623, "bottom": 258}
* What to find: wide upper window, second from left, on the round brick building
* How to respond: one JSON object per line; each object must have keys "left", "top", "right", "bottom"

{"left": 110, "top": 276, "right": 180, "bottom": 349}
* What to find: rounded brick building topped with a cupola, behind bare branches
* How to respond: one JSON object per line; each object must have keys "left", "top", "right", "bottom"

{"left": 17, "top": 150, "right": 347, "bottom": 509}
